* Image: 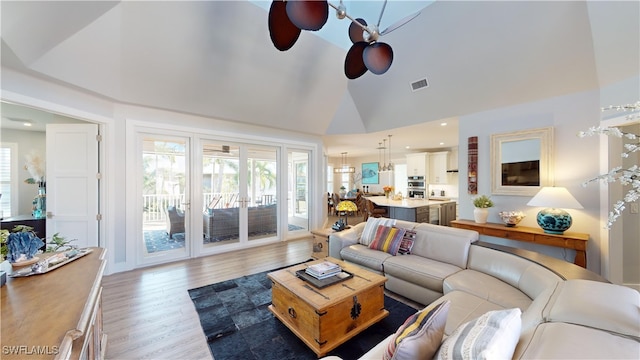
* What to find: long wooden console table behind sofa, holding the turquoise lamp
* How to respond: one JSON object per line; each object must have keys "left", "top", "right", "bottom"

{"left": 451, "top": 220, "right": 589, "bottom": 268}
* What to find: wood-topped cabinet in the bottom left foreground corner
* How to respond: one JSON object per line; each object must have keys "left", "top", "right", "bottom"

{"left": 0, "top": 248, "right": 107, "bottom": 360}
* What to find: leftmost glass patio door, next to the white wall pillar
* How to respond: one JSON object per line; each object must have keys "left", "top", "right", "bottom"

{"left": 139, "top": 133, "right": 190, "bottom": 263}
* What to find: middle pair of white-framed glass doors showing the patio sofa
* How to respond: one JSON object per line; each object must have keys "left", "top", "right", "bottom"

{"left": 194, "top": 140, "right": 279, "bottom": 253}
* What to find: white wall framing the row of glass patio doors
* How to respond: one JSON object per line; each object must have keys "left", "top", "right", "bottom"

{"left": 2, "top": 68, "right": 326, "bottom": 273}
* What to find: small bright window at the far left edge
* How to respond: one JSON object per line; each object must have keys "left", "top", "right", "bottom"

{"left": 0, "top": 143, "right": 18, "bottom": 218}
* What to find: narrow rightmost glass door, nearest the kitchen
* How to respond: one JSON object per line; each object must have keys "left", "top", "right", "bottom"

{"left": 287, "top": 150, "right": 309, "bottom": 233}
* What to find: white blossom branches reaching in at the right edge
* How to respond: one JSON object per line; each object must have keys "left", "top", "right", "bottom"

{"left": 578, "top": 101, "right": 640, "bottom": 229}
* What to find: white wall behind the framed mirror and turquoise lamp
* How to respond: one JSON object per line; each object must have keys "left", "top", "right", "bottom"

{"left": 459, "top": 90, "right": 603, "bottom": 273}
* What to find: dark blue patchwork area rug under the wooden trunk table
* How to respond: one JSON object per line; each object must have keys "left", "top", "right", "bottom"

{"left": 189, "top": 264, "right": 417, "bottom": 360}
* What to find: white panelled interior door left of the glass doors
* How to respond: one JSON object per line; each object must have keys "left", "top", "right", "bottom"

{"left": 46, "top": 124, "right": 100, "bottom": 247}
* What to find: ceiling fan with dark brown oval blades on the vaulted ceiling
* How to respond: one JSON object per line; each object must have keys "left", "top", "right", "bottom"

{"left": 269, "top": 0, "right": 420, "bottom": 79}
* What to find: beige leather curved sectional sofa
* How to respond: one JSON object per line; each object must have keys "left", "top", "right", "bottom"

{"left": 327, "top": 218, "right": 640, "bottom": 359}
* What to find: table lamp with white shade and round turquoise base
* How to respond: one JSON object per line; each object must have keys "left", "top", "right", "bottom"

{"left": 527, "top": 186, "right": 583, "bottom": 235}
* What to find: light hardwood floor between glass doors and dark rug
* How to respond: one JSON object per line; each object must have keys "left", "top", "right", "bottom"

{"left": 102, "top": 238, "right": 312, "bottom": 359}
